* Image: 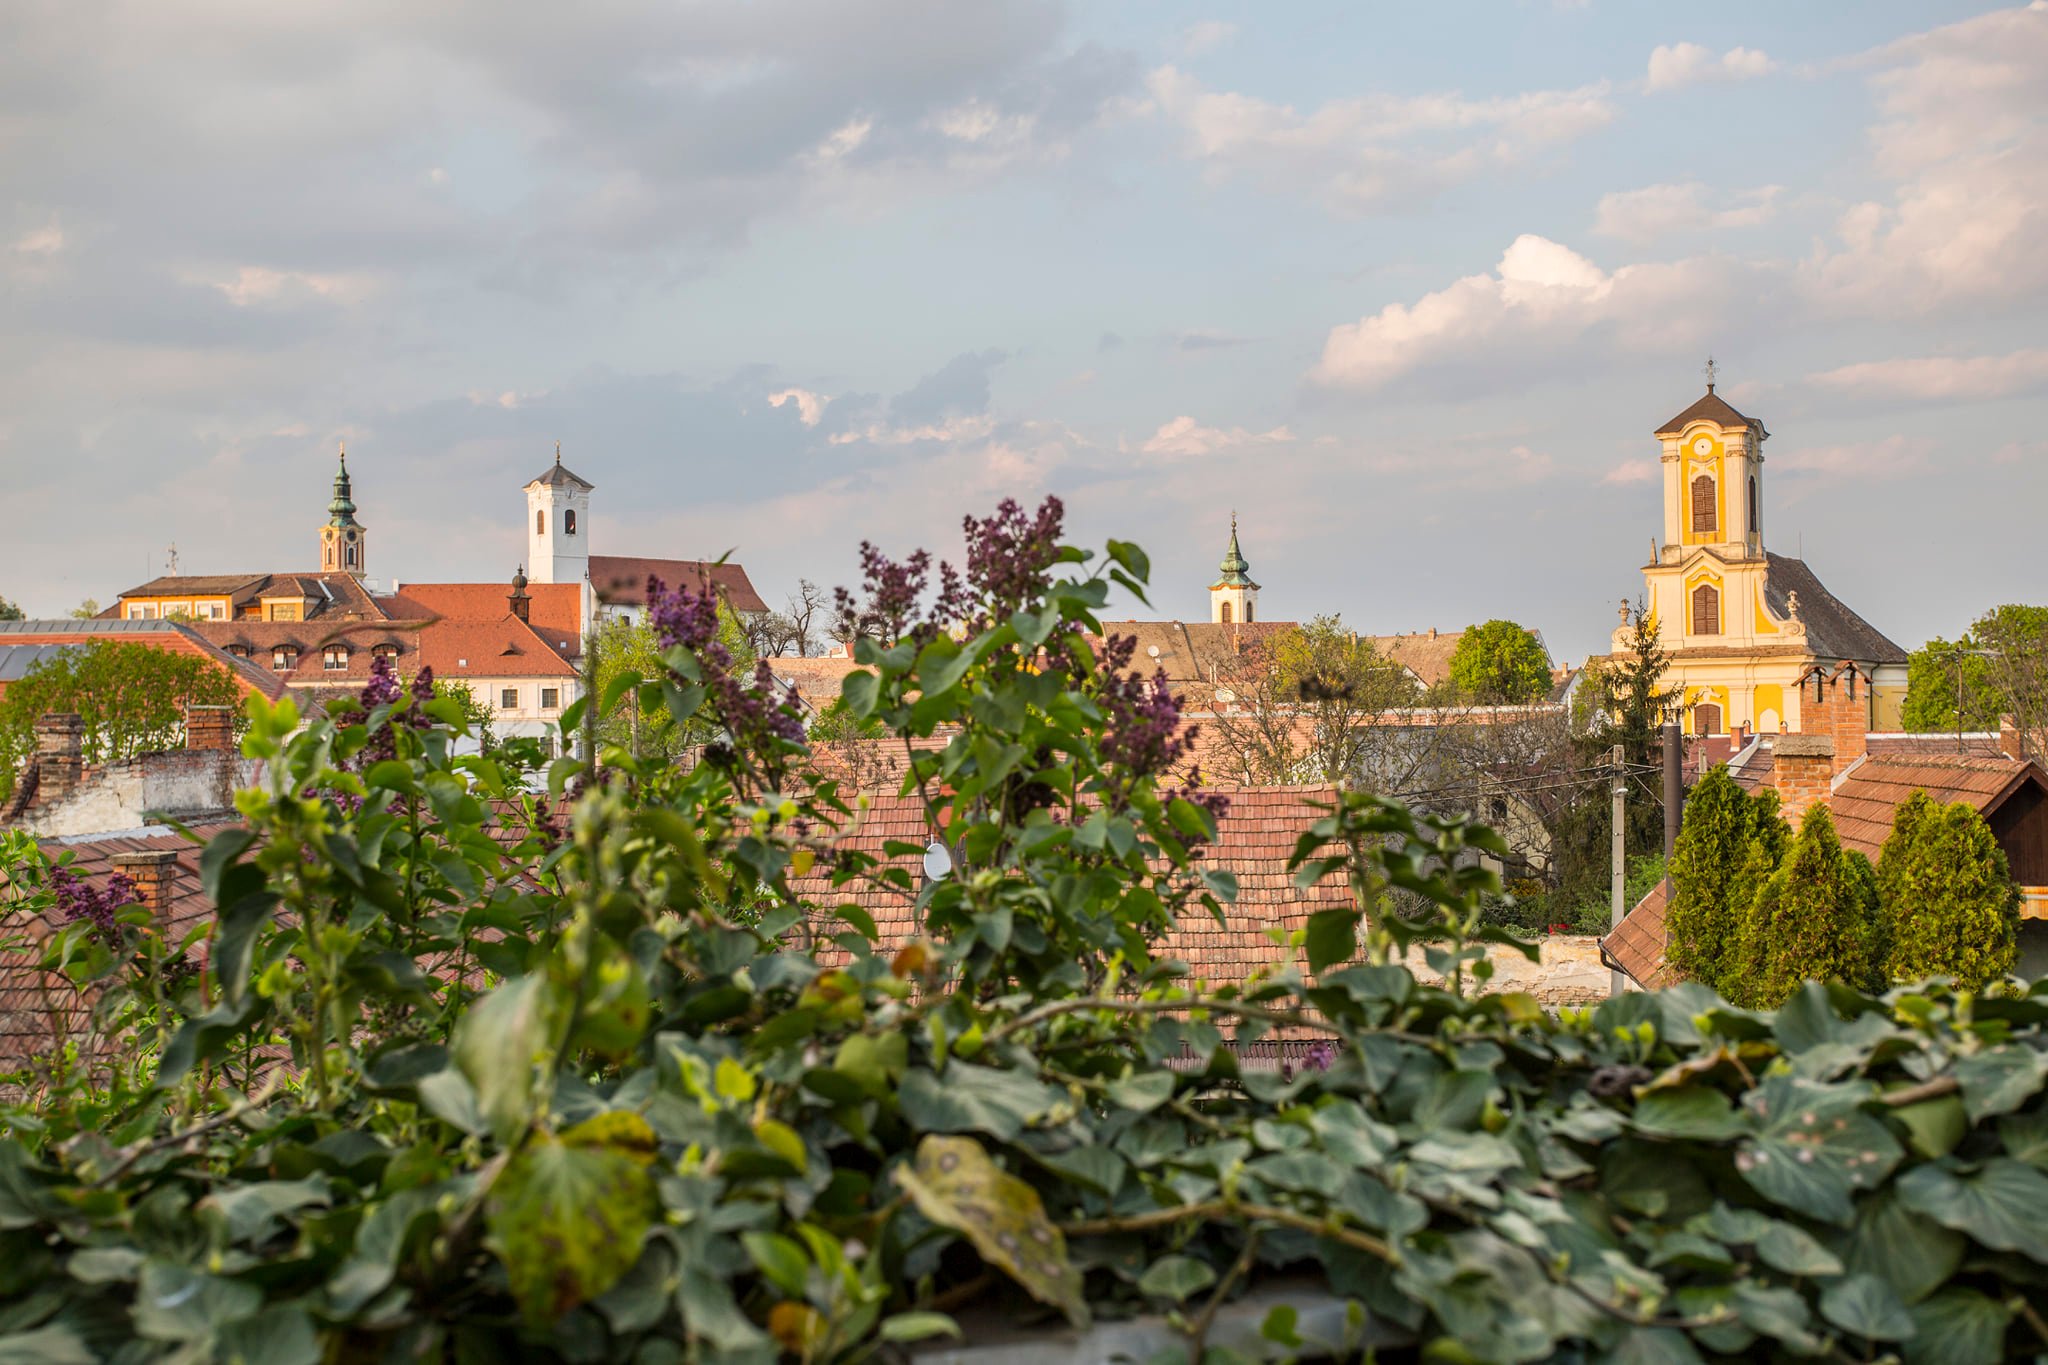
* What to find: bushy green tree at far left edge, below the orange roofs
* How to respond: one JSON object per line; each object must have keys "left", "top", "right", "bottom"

{"left": 0, "top": 641, "right": 242, "bottom": 786}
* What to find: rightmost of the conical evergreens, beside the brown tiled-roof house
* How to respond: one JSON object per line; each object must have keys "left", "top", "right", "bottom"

{"left": 1878, "top": 792, "right": 2019, "bottom": 988}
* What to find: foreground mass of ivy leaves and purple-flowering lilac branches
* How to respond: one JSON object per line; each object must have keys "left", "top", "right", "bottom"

{"left": 0, "top": 505, "right": 2048, "bottom": 1363}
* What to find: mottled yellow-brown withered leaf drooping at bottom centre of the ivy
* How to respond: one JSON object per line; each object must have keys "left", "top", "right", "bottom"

{"left": 897, "top": 1134, "right": 1087, "bottom": 1326}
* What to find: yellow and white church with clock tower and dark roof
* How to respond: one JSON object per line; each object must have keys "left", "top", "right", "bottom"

{"left": 1614, "top": 378, "right": 1907, "bottom": 735}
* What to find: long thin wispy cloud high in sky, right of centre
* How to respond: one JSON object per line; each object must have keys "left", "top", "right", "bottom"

{"left": 1145, "top": 65, "right": 1614, "bottom": 213}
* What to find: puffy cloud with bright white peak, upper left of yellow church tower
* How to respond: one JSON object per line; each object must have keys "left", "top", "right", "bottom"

{"left": 1309, "top": 233, "right": 1743, "bottom": 393}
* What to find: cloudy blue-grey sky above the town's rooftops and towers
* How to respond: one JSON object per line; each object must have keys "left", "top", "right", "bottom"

{"left": 0, "top": 0, "right": 2048, "bottom": 663}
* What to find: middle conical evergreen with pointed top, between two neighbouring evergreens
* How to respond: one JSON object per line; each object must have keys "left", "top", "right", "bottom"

{"left": 1741, "top": 804, "right": 1882, "bottom": 1009}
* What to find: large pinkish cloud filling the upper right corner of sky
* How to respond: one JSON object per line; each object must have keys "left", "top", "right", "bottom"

{"left": 1804, "top": 0, "right": 2048, "bottom": 317}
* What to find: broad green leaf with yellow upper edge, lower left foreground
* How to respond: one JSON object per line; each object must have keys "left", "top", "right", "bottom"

{"left": 485, "top": 1113, "right": 653, "bottom": 1326}
